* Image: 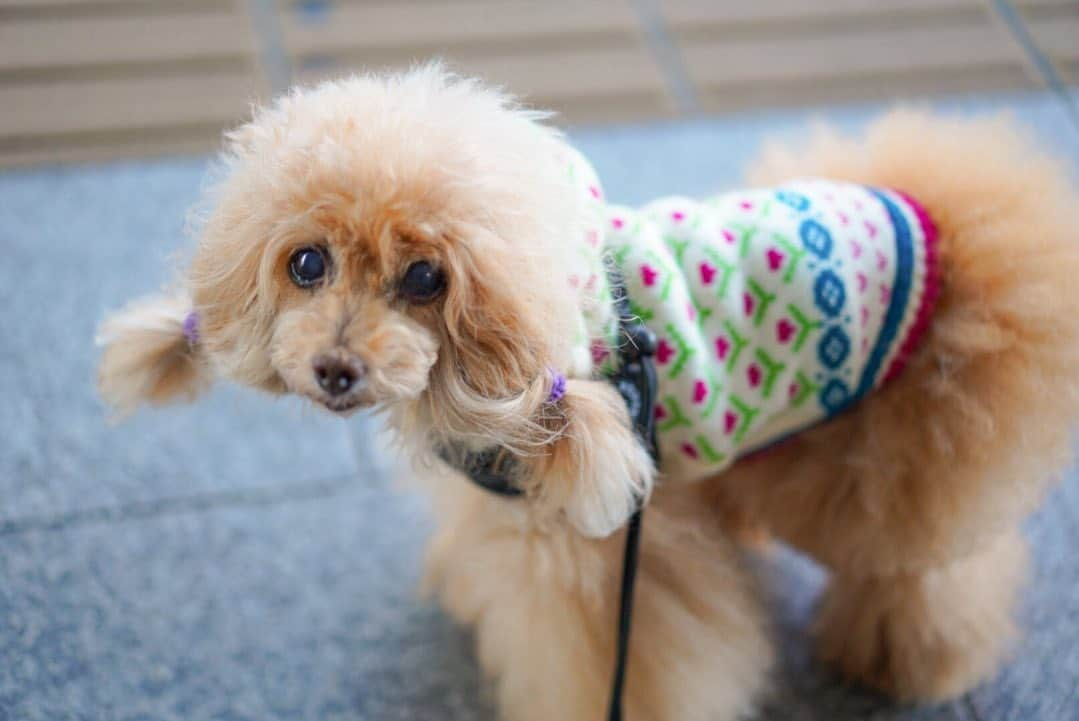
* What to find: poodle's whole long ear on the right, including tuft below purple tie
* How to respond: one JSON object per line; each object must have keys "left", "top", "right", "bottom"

{"left": 428, "top": 231, "right": 655, "bottom": 538}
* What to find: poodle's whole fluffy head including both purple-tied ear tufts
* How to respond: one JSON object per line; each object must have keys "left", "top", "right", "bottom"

{"left": 98, "top": 66, "right": 653, "bottom": 535}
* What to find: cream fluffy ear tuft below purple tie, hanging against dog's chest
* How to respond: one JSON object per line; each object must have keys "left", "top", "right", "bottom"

{"left": 536, "top": 380, "right": 656, "bottom": 538}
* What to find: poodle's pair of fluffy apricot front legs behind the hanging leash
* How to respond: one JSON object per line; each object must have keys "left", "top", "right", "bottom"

{"left": 428, "top": 480, "right": 771, "bottom": 721}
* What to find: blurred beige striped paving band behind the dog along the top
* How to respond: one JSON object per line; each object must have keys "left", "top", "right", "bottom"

{"left": 0, "top": 0, "right": 1079, "bottom": 166}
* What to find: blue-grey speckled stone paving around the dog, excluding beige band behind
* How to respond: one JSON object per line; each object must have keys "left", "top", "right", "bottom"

{"left": 0, "top": 91, "right": 1079, "bottom": 721}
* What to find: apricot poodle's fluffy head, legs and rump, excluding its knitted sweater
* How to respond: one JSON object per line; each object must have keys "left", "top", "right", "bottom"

{"left": 99, "top": 66, "right": 1079, "bottom": 721}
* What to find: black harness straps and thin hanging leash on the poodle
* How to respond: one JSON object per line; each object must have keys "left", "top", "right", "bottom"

{"left": 441, "top": 267, "right": 659, "bottom": 721}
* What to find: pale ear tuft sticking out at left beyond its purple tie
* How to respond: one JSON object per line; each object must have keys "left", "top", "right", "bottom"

{"left": 96, "top": 294, "right": 213, "bottom": 418}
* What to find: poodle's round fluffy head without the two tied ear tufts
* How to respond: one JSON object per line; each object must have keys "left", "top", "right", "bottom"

{"left": 188, "top": 68, "right": 581, "bottom": 428}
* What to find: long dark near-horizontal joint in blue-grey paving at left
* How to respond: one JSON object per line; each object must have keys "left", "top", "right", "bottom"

{"left": 0, "top": 473, "right": 358, "bottom": 538}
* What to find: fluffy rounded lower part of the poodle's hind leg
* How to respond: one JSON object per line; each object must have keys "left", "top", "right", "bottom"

{"left": 815, "top": 530, "right": 1026, "bottom": 700}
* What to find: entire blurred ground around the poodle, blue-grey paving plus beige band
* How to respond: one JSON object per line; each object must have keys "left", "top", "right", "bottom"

{"left": 0, "top": 0, "right": 1079, "bottom": 721}
